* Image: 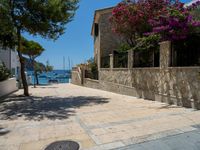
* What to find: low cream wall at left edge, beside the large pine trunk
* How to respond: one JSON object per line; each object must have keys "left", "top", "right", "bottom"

{"left": 0, "top": 78, "right": 18, "bottom": 97}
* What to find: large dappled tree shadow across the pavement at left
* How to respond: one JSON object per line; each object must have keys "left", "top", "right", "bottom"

{"left": 0, "top": 96, "right": 109, "bottom": 121}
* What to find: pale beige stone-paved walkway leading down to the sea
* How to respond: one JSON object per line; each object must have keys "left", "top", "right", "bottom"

{"left": 0, "top": 84, "right": 200, "bottom": 150}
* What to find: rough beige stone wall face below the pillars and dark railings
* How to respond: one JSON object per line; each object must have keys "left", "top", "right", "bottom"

{"left": 100, "top": 67, "right": 200, "bottom": 109}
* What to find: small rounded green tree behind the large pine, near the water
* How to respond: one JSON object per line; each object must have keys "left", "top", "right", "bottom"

{"left": 21, "top": 38, "right": 44, "bottom": 87}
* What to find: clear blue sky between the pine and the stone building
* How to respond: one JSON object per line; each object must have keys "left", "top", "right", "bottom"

{"left": 25, "top": 0, "right": 191, "bottom": 69}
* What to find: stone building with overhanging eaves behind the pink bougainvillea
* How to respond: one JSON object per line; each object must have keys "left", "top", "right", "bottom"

{"left": 91, "top": 7, "right": 122, "bottom": 68}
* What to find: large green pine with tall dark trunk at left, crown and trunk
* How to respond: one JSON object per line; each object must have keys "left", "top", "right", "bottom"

{"left": 0, "top": 0, "right": 78, "bottom": 96}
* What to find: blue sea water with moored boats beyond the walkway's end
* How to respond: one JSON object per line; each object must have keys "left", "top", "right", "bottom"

{"left": 27, "top": 70, "right": 71, "bottom": 85}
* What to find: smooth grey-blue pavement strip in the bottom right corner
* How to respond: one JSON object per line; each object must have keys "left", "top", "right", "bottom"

{"left": 117, "top": 130, "right": 200, "bottom": 150}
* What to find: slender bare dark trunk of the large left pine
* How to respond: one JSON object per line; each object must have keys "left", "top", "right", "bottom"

{"left": 17, "top": 29, "right": 29, "bottom": 96}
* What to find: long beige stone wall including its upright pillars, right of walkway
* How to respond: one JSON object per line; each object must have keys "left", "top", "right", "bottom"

{"left": 72, "top": 32, "right": 200, "bottom": 109}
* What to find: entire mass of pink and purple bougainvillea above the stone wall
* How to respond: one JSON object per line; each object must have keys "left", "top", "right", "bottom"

{"left": 110, "top": 0, "right": 200, "bottom": 43}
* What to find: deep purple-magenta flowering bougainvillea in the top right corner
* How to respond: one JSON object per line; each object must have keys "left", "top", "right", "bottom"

{"left": 149, "top": 1, "right": 200, "bottom": 41}
